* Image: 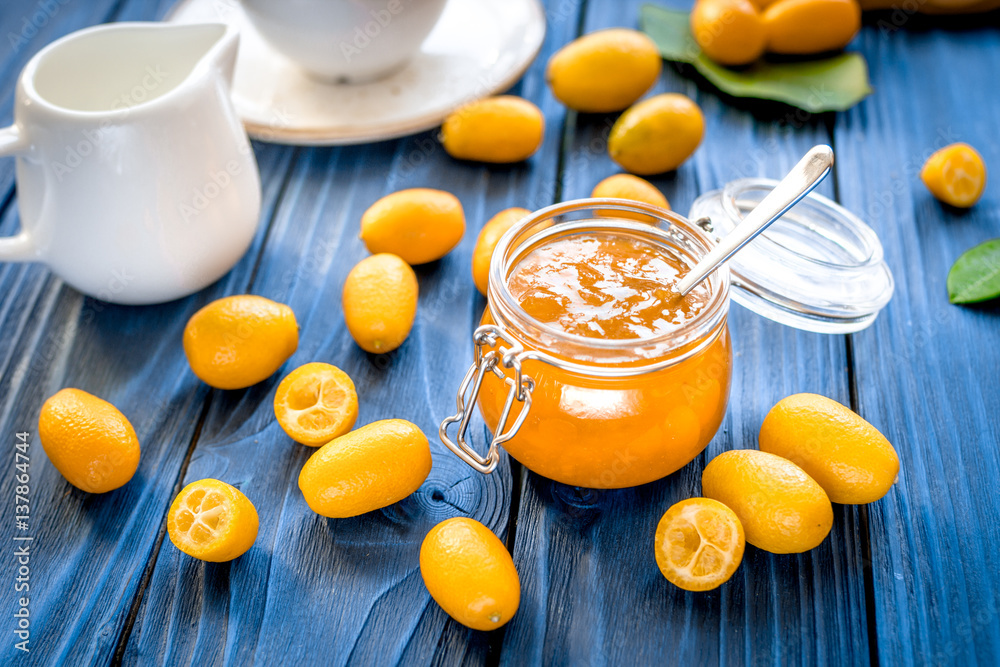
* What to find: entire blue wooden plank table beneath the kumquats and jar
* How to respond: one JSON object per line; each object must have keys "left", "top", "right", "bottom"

{"left": 0, "top": 0, "right": 1000, "bottom": 665}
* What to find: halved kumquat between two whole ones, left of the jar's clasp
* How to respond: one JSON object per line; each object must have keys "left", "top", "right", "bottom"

{"left": 274, "top": 362, "right": 358, "bottom": 447}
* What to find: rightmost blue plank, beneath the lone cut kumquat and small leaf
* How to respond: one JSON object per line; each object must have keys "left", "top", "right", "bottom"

{"left": 836, "top": 19, "right": 1000, "bottom": 665}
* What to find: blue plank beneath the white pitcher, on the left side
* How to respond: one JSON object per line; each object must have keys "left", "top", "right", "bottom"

{"left": 0, "top": 3, "right": 293, "bottom": 664}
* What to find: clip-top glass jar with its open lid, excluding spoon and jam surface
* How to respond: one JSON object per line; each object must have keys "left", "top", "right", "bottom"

{"left": 439, "top": 188, "right": 892, "bottom": 488}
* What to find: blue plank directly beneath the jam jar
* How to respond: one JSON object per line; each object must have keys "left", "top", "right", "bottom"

{"left": 502, "top": 1, "right": 868, "bottom": 665}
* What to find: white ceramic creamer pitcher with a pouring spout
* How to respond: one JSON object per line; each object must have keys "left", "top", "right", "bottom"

{"left": 0, "top": 23, "right": 261, "bottom": 304}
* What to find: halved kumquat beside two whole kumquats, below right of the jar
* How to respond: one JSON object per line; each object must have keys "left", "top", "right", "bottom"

{"left": 656, "top": 498, "right": 746, "bottom": 591}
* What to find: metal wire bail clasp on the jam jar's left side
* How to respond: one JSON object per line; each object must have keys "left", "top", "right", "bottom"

{"left": 438, "top": 324, "right": 535, "bottom": 474}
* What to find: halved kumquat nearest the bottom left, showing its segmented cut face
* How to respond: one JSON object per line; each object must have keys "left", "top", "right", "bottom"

{"left": 167, "top": 479, "right": 259, "bottom": 563}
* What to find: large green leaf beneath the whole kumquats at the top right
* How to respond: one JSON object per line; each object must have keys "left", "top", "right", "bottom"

{"left": 639, "top": 5, "right": 872, "bottom": 113}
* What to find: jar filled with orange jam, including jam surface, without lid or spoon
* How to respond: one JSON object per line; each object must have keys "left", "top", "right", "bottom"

{"left": 464, "top": 200, "right": 732, "bottom": 488}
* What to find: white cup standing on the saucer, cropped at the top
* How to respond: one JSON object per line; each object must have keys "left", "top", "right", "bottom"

{"left": 241, "top": 0, "right": 446, "bottom": 83}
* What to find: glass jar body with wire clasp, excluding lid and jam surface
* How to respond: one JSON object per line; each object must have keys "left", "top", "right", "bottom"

{"left": 441, "top": 200, "right": 732, "bottom": 488}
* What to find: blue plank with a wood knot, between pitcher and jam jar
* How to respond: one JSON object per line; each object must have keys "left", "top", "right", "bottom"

{"left": 124, "top": 5, "right": 577, "bottom": 665}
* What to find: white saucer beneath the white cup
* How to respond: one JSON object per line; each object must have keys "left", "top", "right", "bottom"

{"left": 167, "top": 0, "right": 545, "bottom": 146}
